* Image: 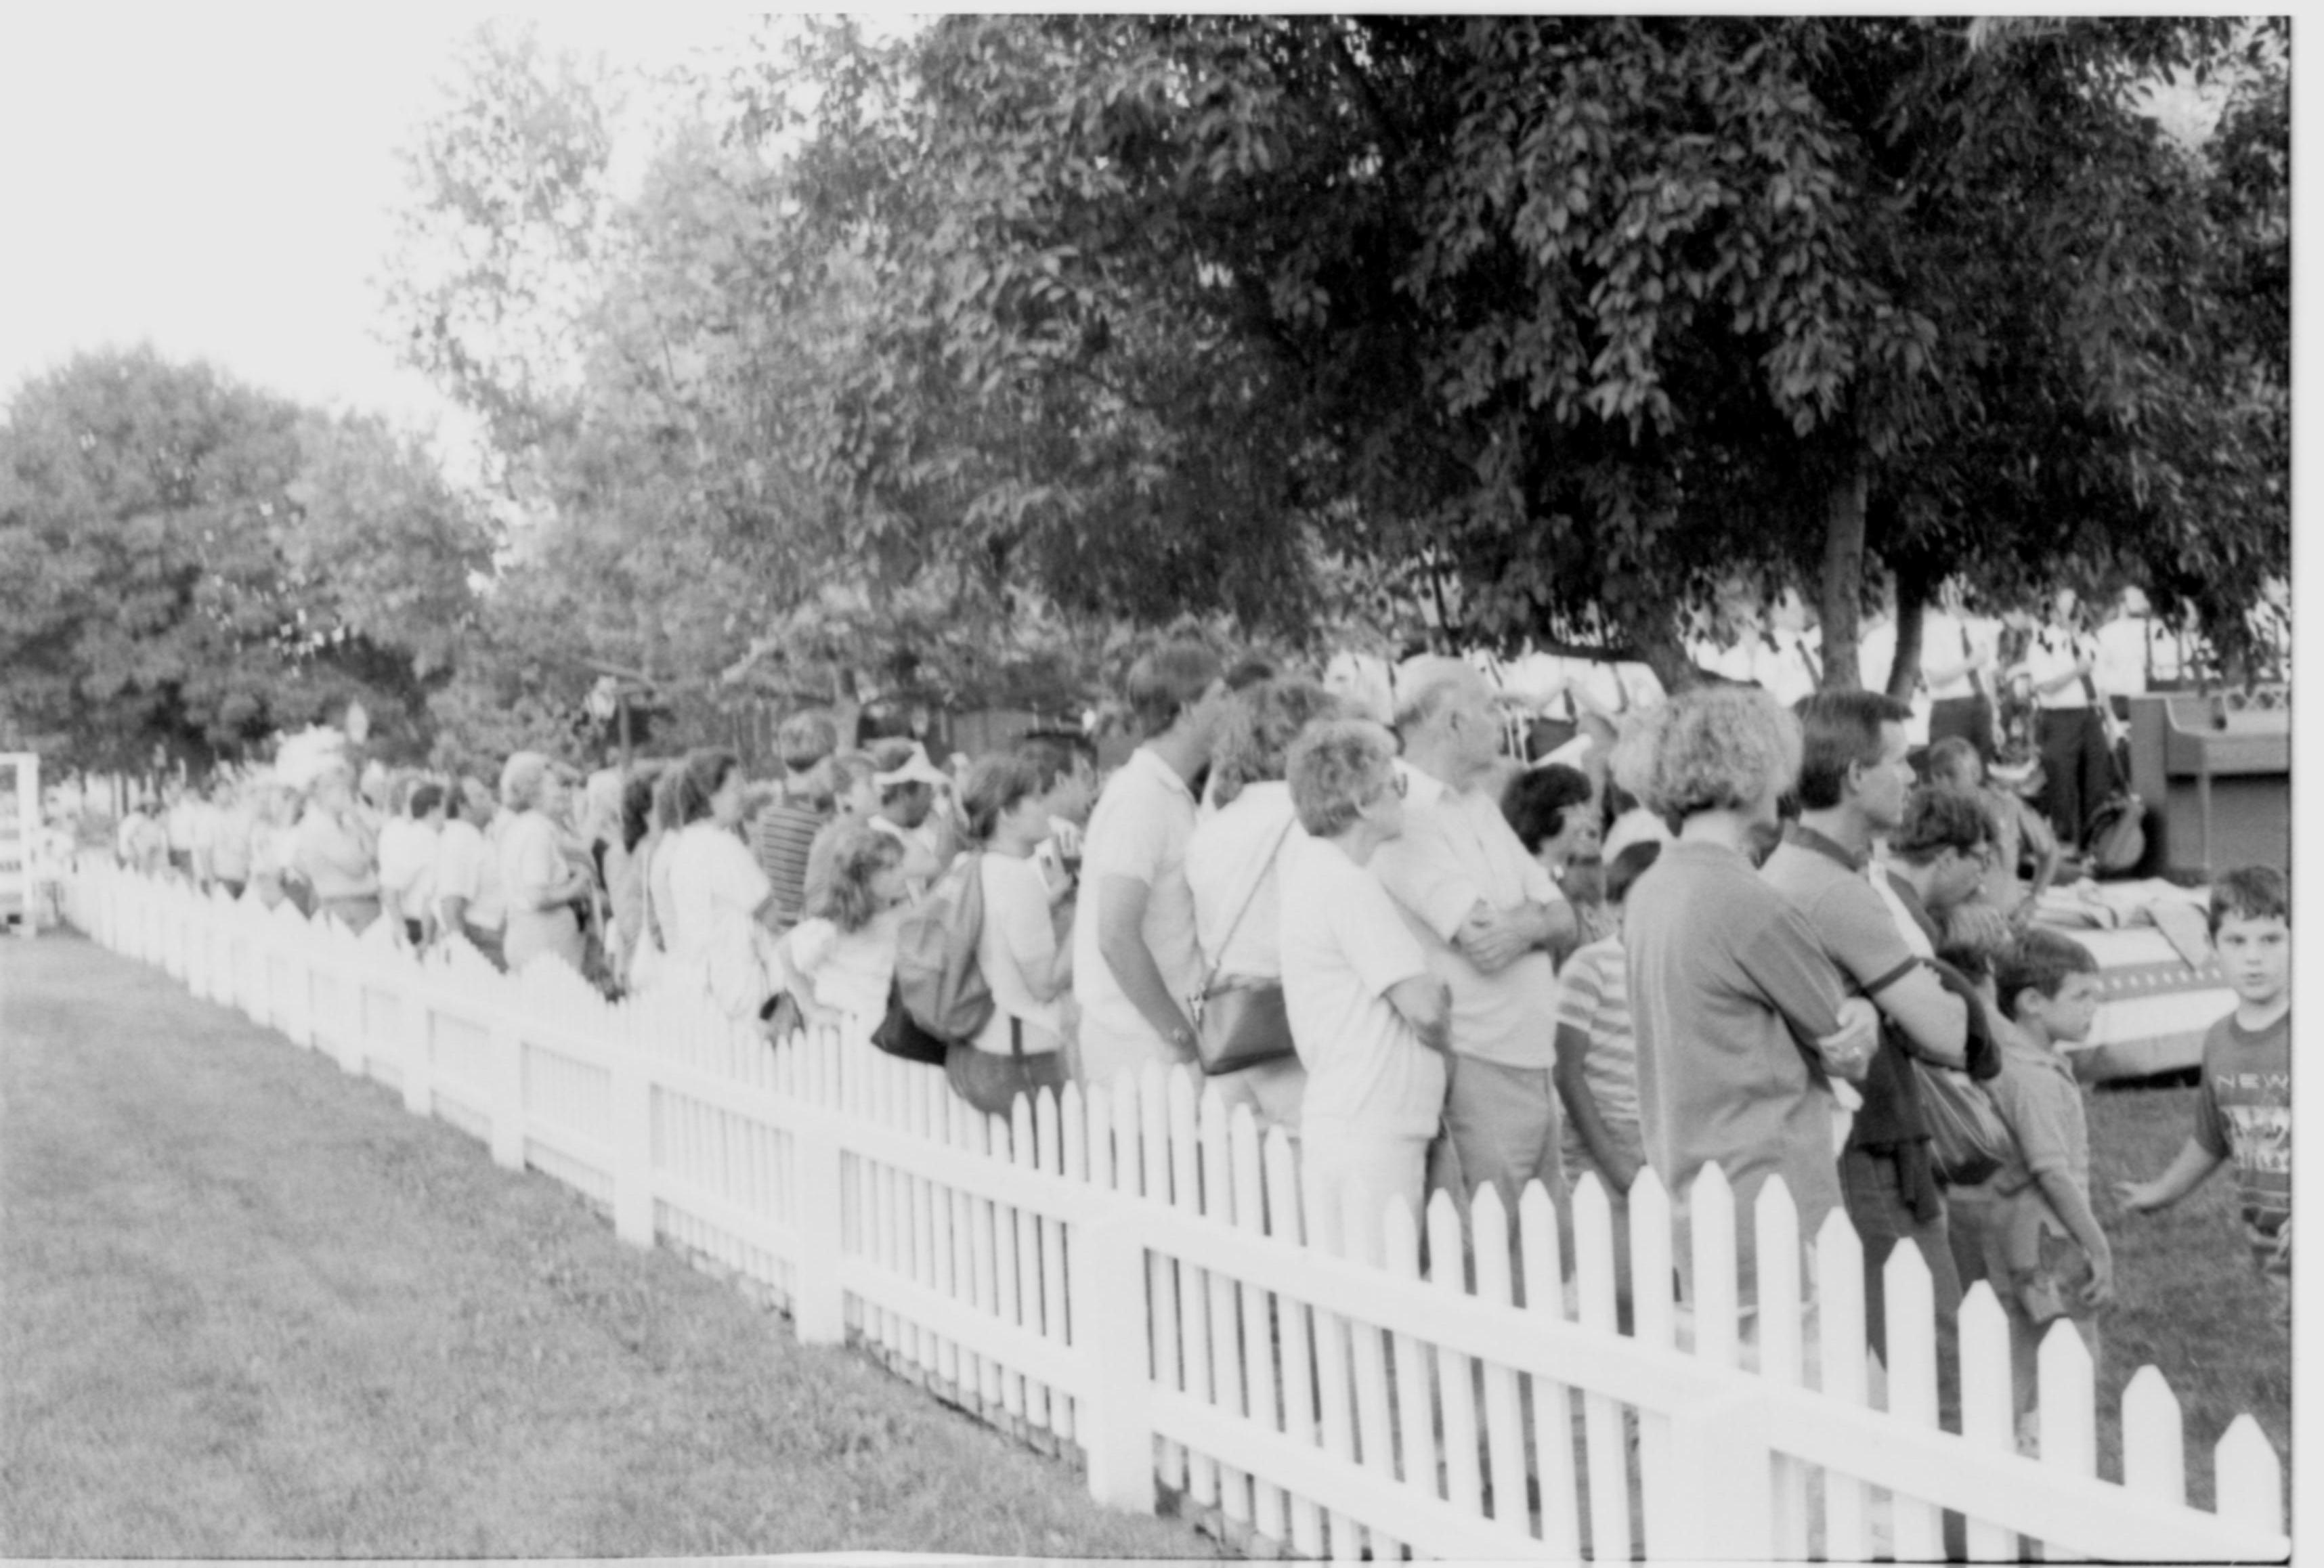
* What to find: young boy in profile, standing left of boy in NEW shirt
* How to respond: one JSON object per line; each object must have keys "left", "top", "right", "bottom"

{"left": 1950, "top": 927, "right": 2115, "bottom": 1417}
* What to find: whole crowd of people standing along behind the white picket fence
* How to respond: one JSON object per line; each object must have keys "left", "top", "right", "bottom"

{"left": 104, "top": 613, "right": 2289, "bottom": 1450}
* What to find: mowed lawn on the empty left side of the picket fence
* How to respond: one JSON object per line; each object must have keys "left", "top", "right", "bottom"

{"left": 0, "top": 936, "right": 1215, "bottom": 1559}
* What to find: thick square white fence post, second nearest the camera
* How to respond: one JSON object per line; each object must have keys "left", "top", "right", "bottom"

{"left": 1067, "top": 1206, "right": 1157, "bottom": 1515}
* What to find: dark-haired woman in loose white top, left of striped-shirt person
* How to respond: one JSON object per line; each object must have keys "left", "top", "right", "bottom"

{"left": 649, "top": 750, "right": 774, "bottom": 1022}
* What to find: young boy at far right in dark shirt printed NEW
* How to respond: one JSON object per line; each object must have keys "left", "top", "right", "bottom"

{"left": 2117, "top": 867, "right": 2291, "bottom": 1333}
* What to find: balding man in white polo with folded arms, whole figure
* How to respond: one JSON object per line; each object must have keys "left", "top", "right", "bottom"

{"left": 1371, "top": 657, "right": 1573, "bottom": 1219}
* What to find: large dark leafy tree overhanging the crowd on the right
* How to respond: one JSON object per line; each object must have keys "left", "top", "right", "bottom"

{"left": 762, "top": 16, "right": 2287, "bottom": 683}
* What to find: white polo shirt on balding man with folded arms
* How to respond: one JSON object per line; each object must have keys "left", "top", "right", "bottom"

{"left": 1371, "top": 769, "right": 1566, "bottom": 1071}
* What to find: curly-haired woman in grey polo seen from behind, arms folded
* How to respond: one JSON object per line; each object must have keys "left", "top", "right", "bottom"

{"left": 1613, "top": 688, "right": 1878, "bottom": 1292}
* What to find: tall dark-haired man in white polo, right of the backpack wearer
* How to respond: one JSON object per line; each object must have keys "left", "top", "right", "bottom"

{"left": 1074, "top": 641, "right": 1227, "bottom": 1085}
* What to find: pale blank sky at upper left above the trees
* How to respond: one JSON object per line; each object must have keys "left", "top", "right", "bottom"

{"left": 0, "top": 0, "right": 746, "bottom": 448}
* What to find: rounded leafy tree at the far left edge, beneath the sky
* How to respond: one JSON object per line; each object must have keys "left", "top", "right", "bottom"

{"left": 0, "top": 349, "right": 488, "bottom": 769}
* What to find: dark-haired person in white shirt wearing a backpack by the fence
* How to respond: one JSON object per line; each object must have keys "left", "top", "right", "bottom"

{"left": 946, "top": 753, "right": 1074, "bottom": 1113}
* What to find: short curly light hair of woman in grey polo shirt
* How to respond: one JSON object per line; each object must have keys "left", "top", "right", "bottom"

{"left": 1613, "top": 685, "right": 1801, "bottom": 820}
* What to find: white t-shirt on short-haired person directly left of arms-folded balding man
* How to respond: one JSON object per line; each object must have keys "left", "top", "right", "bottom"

{"left": 1278, "top": 831, "right": 1446, "bottom": 1138}
